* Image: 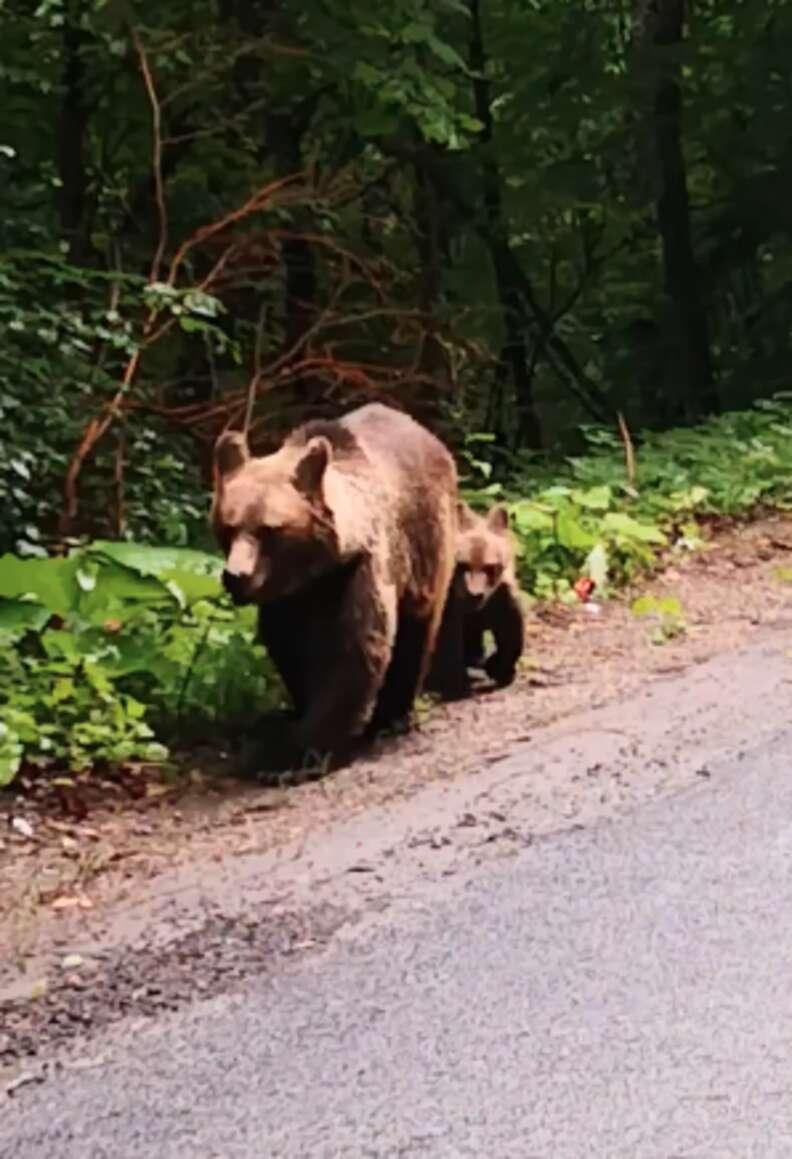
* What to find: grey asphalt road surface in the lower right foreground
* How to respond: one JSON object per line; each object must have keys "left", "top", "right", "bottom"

{"left": 0, "top": 729, "right": 792, "bottom": 1159}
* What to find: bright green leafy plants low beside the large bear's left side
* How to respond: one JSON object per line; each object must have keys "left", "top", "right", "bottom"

{"left": 0, "top": 541, "right": 281, "bottom": 785}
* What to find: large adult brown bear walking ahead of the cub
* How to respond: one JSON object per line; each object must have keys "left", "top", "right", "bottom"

{"left": 212, "top": 403, "right": 457, "bottom": 759}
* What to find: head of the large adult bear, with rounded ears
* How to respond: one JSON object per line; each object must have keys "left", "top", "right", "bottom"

{"left": 212, "top": 431, "right": 337, "bottom": 604}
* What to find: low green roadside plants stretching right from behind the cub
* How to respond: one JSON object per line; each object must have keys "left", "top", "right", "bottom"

{"left": 465, "top": 398, "right": 792, "bottom": 598}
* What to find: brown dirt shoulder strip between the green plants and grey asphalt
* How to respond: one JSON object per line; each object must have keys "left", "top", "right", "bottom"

{"left": 0, "top": 518, "right": 792, "bottom": 1065}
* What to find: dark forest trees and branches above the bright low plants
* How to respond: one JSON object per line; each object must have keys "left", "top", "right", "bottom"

{"left": 0, "top": 0, "right": 792, "bottom": 553}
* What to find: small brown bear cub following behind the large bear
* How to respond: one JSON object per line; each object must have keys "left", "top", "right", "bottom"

{"left": 427, "top": 502, "right": 525, "bottom": 699}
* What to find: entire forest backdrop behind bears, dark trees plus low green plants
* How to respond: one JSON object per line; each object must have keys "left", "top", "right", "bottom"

{"left": 0, "top": 0, "right": 792, "bottom": 782}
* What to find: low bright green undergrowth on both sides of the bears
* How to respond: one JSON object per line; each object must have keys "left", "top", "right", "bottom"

{"left": 0, "top": 398, "right": 792, "bottom": 785}
